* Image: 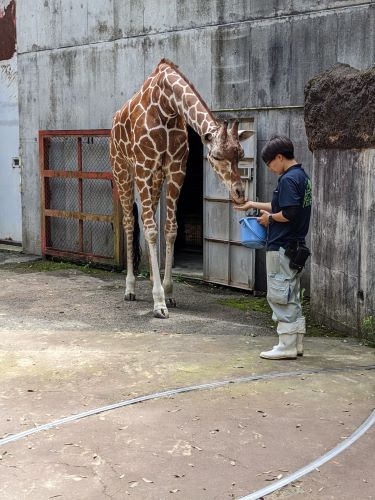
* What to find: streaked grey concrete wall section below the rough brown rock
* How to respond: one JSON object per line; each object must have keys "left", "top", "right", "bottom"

{"left": 311, "top": 149, "right": 375, "bottom": 334}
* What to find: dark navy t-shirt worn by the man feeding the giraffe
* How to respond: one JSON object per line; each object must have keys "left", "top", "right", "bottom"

{"left": 267, "top": 164, "right": 312, "bottom": 250}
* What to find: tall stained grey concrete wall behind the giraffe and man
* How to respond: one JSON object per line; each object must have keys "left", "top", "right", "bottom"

{"left": 17, "top": 0, "right": 375, "bottom": 288}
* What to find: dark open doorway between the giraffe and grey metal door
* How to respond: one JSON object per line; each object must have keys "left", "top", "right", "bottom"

{"left": 173, "top": 127, "right": 203, "bottom": 275}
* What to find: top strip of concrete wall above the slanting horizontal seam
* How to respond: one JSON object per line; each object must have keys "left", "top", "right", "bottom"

{"left": 14, "top": 0, "right": 371, "bottom": 52}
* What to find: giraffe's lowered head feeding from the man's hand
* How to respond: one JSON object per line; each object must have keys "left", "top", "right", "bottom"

{"left": 203, "top": 121, "right": 254, "bottom": 204}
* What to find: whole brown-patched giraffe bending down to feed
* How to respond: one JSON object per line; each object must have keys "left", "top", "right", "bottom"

{"left": 110, "top": 59, "right": 253, "bottom": 318}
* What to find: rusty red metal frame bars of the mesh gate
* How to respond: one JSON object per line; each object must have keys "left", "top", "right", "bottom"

{"left": 39, "top": 129, "right": 124, "bottom": 268}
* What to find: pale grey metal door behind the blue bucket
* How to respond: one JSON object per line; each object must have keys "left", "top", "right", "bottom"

{"left": 203, "top": 118, "right": 256, "bottom": 290}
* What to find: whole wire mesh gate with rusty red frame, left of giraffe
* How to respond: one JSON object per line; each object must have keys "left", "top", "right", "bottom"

{"left": 39, "top": 130, "right": 123, "bottom": 267}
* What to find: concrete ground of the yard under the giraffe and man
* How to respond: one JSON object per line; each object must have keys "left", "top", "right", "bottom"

{"left": 0, "top": 256, "right": 375, "bottom": 500}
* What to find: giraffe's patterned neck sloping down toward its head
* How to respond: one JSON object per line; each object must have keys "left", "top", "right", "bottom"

{"left": 162, "top": 66, "right": 218, "bottom": 136}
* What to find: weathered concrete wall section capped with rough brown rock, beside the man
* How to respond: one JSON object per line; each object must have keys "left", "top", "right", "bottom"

{"left": 305, "top": 64, "right": 375, "bottom": 334}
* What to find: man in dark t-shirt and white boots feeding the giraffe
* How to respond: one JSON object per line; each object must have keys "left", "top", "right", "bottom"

{"left": 234, "top": 136, "right": 311, "bottom": 359}
